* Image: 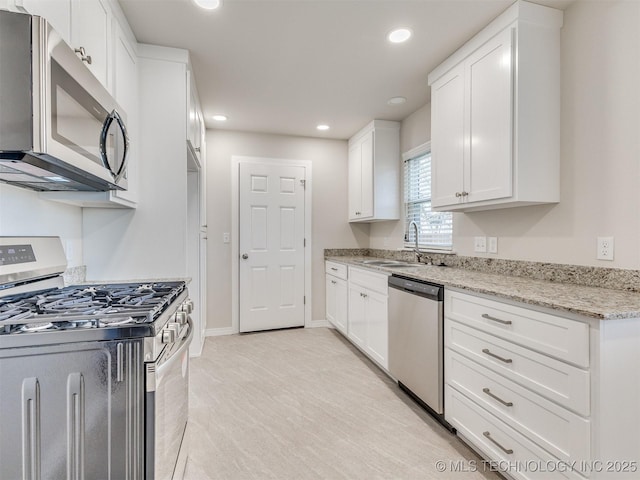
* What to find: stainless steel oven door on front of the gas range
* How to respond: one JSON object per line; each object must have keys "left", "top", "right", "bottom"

{"left": 145, "top": 320, "right": 193, "bottom": 480}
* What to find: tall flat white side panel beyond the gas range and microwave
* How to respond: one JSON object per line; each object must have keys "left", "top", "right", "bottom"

{"left": 84, "top": 46, "right": 187, "bottom": 281}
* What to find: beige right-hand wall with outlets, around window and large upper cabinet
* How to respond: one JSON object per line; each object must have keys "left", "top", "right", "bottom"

{"left": 371, "top": 1, "right": 640, "bottom": 269}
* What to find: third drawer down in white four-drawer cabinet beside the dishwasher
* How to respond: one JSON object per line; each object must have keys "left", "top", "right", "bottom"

{"left": 445, "top": 348, "right": 591, "bottom": 463}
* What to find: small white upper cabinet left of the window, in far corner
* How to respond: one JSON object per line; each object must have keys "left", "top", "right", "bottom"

{"left": 349, "top": 120, "right": 400, "bottom": 222}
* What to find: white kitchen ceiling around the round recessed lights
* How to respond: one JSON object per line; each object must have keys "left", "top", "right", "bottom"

{"left": 119, "top": 0, "right": 572, "bottom": 139}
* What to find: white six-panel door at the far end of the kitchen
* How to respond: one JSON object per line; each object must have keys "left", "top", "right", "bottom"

{"left": 239, "top": 163, "right": 305, "bottom": 332}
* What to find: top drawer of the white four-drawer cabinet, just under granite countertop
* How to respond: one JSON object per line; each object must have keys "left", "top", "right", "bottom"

{"left": 445, "top": 291, "right": 589, "bottom": 367}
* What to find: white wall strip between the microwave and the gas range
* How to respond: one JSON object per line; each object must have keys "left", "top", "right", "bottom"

{"left": 0, "top": 183, "right": 83, "bottom": 267}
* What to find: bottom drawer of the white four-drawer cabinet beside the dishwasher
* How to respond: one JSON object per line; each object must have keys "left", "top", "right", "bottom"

{"left": 445, "top": 385, "right": 584, "bottom": 480}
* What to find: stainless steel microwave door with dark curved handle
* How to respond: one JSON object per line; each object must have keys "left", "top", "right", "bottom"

{"left": 34, "top": 18, "right": 129, "bottom": 189}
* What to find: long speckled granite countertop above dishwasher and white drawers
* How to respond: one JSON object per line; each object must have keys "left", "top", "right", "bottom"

{"left": 326, "top": 256, "right": 640, "bottom": 320}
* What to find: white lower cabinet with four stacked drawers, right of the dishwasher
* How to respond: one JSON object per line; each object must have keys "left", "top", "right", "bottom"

{"left": 444, "top": 290, "right": 592, "bottom": 479}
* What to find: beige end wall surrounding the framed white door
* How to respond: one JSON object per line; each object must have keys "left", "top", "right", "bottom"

{"left": 207, "top": 130, "right": 369, "bottom": 329}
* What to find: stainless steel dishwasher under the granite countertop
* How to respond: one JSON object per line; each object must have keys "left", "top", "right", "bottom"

{"left": 389, "top": 275, "right": 451, "bottom": 429}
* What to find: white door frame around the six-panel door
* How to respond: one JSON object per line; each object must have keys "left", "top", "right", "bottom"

{"left": 231, "top": 155, "right": 313, "bottom": 333}
